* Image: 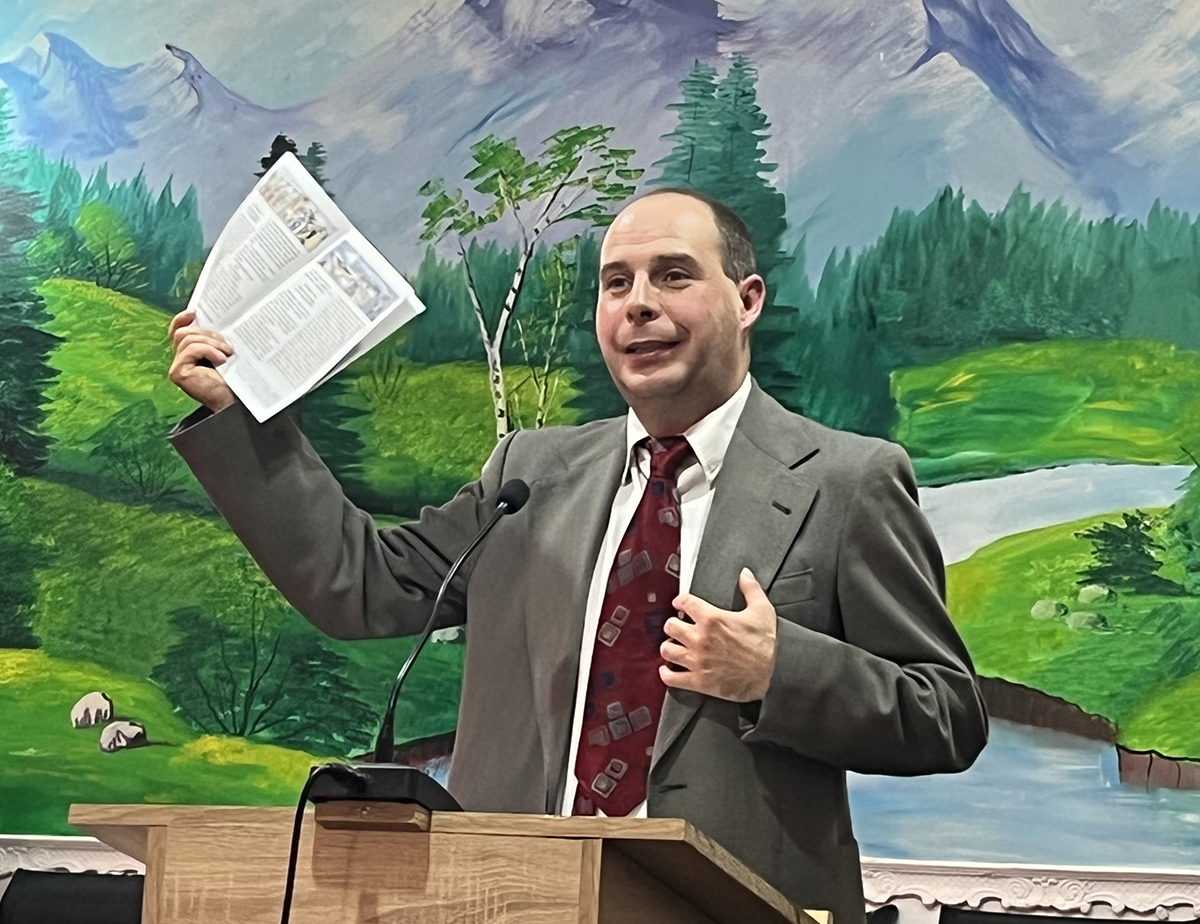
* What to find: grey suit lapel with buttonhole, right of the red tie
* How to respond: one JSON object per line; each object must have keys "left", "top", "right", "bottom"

{"left": 650, "top": 385, "right": 817, "bottom": 772}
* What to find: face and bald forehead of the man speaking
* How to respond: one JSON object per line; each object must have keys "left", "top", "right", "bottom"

{"left": 596, "top": 193, "right": 758, "bottom": 410}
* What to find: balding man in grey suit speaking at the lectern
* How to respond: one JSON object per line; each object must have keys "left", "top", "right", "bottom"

{"left": 170, "top": 191, "right": 986, "bottom": 924}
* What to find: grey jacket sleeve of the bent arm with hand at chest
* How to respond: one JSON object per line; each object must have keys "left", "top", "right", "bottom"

{"left": 743, "top": 443, "right": 988, "bottom": 775}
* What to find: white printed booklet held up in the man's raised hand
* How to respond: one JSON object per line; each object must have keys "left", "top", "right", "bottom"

{"left": 188, "top": 154, "right": 425, "bottom": 422}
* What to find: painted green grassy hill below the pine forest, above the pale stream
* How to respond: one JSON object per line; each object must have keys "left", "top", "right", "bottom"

{"left": 892, "top": 340, "right": 1200, "bottom": 484}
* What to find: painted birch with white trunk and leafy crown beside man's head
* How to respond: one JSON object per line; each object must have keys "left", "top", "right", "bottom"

{"left": 420, "top": 125, "right": 642, "bottom": 439}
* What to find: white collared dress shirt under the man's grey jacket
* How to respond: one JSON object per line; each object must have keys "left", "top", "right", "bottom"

{"left": 560, "top": 374, "right": 750, "bottom": 818}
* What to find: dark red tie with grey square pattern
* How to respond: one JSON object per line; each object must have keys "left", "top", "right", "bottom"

{"left": 575, "top": 437, "right": 691, "bottom": 816}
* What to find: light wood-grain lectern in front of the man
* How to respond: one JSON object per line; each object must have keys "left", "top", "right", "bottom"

{"left": 70, "top": 802, "right": 829, "bottom": 924}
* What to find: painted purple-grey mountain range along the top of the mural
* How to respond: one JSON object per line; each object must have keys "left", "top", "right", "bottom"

{"left": 0, "top": 0, "right": 1185, "bottom": 265}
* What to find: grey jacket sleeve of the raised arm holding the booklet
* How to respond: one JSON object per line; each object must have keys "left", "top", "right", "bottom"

{"left": 169, "top": 404, "right": 511, "bottom": 638}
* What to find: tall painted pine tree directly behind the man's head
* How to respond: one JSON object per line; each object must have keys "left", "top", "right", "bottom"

{"left": 653, "top": 55, "right": 803, "bottom": 410}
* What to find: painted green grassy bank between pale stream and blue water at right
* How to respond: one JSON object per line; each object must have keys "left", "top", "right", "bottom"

{"left": 947, "top": 514, "right": 1200, "bottom": 758}
